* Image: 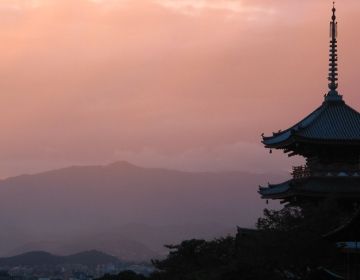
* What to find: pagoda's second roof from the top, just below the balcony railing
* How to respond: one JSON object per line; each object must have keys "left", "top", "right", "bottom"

{"left": 258, "top": 175, "right": 360, "bottom": 199}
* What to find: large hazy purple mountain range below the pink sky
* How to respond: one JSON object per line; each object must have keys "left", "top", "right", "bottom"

{"left": 0, "top": 162, "right": 279, "bottom": 260}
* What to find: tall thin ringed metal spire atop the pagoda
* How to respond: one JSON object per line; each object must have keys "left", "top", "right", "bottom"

{"left": 325, "top": 2, "right": 342, "bottom": 101}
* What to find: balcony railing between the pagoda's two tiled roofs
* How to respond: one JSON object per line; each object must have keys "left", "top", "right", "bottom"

{"left": 291, "top": 165, "right": 360, "bottom": 180}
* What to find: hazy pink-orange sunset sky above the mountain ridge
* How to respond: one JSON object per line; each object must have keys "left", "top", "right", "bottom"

{"left": 0, "top": 0, "right": 360, "bottom": 177}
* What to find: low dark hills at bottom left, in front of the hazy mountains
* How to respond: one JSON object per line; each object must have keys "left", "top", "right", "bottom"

{"left": 0, "top": 250, "right": 119, "bottom": 267}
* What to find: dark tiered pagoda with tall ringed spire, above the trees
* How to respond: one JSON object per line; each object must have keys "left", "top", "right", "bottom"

{"left": 259, "top": 6, "right": 360, "bottom": 205}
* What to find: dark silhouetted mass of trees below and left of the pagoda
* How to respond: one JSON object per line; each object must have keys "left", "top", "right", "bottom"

{"left": 97, "top": 200, "right": 346, "bottom": 280}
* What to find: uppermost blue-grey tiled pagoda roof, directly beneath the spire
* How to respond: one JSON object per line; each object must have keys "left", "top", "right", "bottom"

{"left": 262, "top": 98, "right": 360, "bottom": 149}
